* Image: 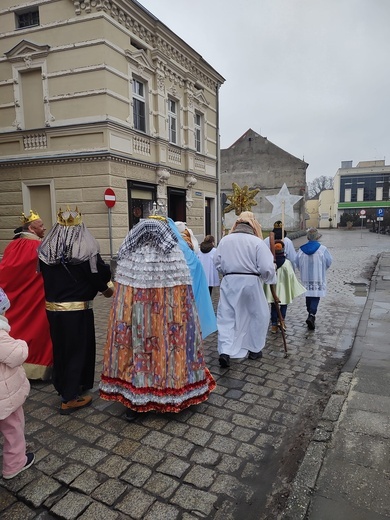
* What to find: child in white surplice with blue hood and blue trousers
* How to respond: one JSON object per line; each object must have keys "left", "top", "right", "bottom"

{"left": 296, "top": 228, "right": 332, "bottom": 330}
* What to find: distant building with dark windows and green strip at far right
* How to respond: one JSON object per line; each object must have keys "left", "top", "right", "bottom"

{"left": 333, "top": 160, "right": 390, "bottom": 223}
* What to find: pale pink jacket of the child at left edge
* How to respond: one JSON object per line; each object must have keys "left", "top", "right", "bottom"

{"left": 0, "top": 316, "right": 30, "bottom": 420}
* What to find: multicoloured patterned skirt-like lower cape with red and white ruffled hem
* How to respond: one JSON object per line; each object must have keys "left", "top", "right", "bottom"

{"left": 99, "top": 283, "right": 216, "bottom": 412}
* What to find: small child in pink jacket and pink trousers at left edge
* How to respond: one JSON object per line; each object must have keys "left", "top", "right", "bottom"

{"left": 0, "top": 288, "right": 35, "bottom": 480}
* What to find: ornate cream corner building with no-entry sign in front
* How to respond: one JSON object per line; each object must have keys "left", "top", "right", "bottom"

{"left": 0, "top": 0, "right": 224, "bottom": 254}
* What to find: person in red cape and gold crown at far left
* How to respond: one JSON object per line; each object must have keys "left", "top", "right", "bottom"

{"left": 0, "top": 210, "right": 53, "bottom": 380}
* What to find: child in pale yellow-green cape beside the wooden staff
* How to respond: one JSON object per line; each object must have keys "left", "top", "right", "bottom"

{"left": 264, "top": 240, "right": 306, "bottom": 334}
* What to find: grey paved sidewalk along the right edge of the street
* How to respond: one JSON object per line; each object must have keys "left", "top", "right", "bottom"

{"left": 281, "top": 251, "right": 390, "bottom": 520}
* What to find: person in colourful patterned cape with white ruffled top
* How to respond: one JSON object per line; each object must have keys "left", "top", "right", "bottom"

{"left": 99, "top": 216, "right": 216, "bottom": 421}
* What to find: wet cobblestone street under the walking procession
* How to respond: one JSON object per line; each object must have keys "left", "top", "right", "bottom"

{"left": 0, "top": 230, "right": 390, "bottom": 520}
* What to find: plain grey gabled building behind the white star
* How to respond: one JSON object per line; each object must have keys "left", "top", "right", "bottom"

{"left": 221, "top": 129, "right": 309, "bottom": 230}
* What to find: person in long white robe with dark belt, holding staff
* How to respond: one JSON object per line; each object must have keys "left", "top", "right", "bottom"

{"left": 214, "top": 211, "right": 276, "bottom": 368}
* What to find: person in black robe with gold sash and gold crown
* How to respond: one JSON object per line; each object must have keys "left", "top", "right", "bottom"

{"left": 38, "top": 208, "right": 113, "bottom": 415}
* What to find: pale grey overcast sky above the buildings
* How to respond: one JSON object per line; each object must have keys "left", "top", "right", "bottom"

{"left": 139, "top": 0, "right": 390, "bottom": 181}
